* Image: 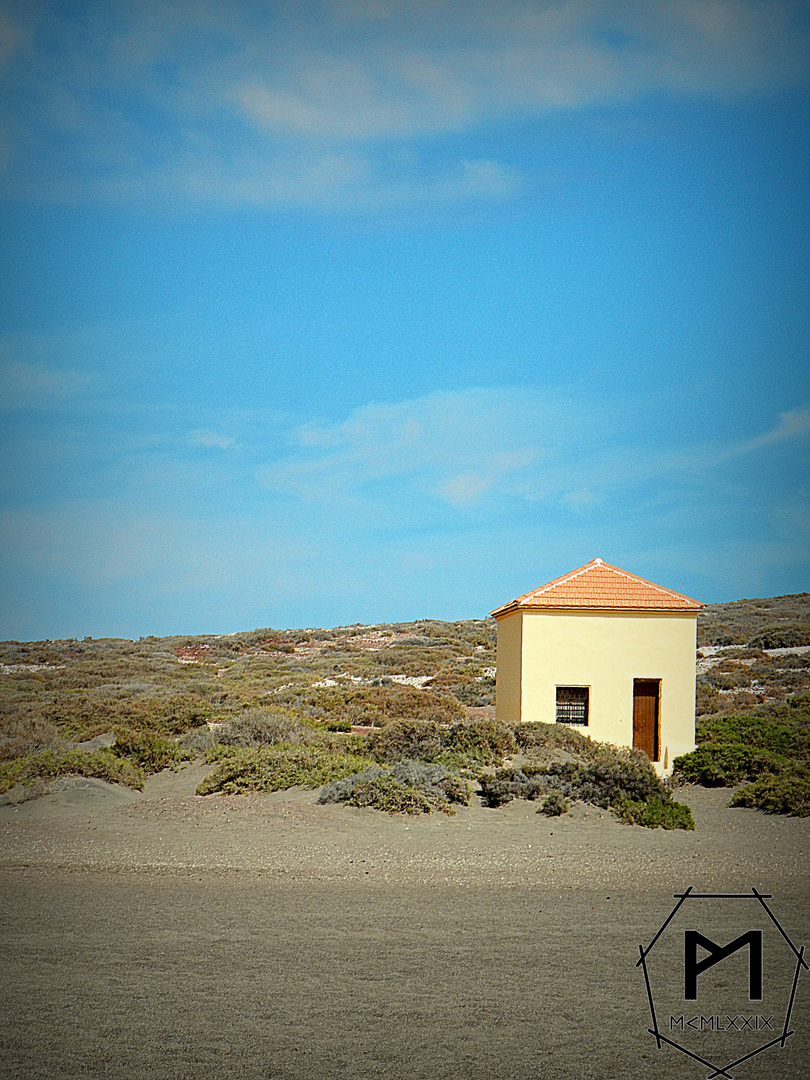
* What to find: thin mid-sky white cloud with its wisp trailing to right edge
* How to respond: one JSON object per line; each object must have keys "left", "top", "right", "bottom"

{"left": 258, "top": 388, "right": 810, "bottom": 515}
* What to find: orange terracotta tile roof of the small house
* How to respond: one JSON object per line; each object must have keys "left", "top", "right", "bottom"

{"left": 490, "top": 558, "right": 703, "bottom": 619}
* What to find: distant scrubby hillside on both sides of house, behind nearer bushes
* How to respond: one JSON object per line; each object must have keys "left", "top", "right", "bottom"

{"left": 0, "top": 593, "right": 810, "bottom": 758}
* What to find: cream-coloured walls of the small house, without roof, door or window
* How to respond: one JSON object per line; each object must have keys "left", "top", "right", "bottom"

{"left": 505, "top": 611, "right": 698, "bottom": 767}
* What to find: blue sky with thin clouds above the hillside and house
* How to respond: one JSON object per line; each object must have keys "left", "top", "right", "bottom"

{"left": 0, "top": 0, "right": 810, "bottom": 639}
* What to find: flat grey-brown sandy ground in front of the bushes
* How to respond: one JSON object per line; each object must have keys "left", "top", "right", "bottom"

{"left": 0, "top": 766, "right": 810, "bottom": 1080}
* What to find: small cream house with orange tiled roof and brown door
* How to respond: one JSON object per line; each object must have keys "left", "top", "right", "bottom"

{"left": 491, "top": 558, "right": 703, "bottom": 772}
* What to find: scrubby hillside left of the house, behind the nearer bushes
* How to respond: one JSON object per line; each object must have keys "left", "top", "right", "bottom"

{"left": 0, "top": 620, "right": 495, "bottom": 759}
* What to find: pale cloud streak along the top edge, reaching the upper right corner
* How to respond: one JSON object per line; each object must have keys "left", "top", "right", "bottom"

{"left": 231, "top": 0, "right": 808, "bottom": 139}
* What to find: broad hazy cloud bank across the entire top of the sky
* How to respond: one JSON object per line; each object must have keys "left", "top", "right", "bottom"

{"left": 0, "top": 0, "right": 810, "bottom": 210}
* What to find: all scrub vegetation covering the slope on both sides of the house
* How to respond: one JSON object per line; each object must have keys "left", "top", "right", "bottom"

{"left": 0, "top": 594, "right": 810, "bottom": 828}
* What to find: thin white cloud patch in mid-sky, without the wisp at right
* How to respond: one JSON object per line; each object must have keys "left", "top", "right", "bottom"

{"left": 260, "top": 388, "right": 596, "bottom": 510}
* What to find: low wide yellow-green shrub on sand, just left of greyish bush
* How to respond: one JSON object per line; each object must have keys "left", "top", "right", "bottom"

{"left": 197, "top": 743, "right": 374, "bottom": 795}
